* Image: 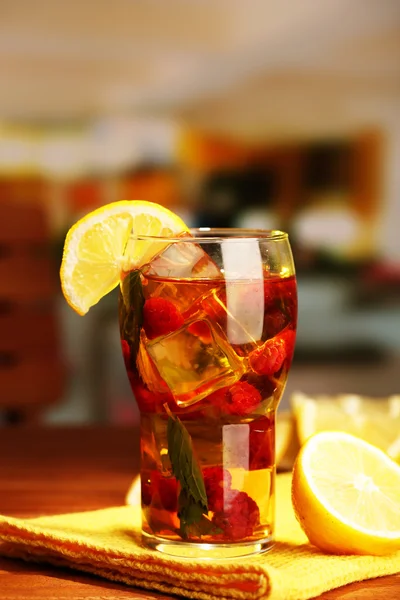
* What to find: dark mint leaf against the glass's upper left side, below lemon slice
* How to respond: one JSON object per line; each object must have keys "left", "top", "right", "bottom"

{"left": 119, "top": 270, "right": 144, "bottom": 368}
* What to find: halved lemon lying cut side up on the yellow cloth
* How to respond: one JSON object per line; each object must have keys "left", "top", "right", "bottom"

{"left": 292, "top": 431, "right": 400, "bottom": 555}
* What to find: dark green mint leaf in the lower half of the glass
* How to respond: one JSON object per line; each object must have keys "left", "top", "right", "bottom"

{"left": 167, "top": 411, "right": 210, "bottom": 539}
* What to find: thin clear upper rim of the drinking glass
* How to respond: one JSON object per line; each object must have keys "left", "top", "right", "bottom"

{"left": 131, "top": 227, "right": 289, "bottom": 244}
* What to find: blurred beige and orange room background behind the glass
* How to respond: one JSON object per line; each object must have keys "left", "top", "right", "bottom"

{"left": 0, "top": 0, "right": 400, "bottom": 424}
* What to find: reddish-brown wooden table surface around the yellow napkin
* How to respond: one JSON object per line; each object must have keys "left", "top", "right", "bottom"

{"left": 0, "top": 428, "right": 400, "bottom": 600}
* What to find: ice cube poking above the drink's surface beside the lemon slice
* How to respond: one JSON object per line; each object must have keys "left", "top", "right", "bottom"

{"left": 147, "top": 238, "right": 221, "bottom": 279}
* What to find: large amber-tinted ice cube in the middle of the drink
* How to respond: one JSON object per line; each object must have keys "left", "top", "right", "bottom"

{"left": 147, "top": 318, "right": 245, "bottom": 406}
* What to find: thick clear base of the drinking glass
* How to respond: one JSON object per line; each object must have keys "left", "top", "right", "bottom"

{"left": 142, "top": 531, "right": 274, "bottom": 560}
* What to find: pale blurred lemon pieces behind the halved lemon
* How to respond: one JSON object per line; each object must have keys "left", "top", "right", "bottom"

{"left": 291, "top": 393, "right": 400, "bottom": 462}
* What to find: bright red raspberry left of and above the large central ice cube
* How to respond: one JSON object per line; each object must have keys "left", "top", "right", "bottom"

{"left": 143, "top": 298, "right": 184, "bottom": 339}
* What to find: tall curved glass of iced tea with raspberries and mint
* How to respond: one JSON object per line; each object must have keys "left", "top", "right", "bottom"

{"left": 119, "top": 229, "right": 297, "bottom": 558}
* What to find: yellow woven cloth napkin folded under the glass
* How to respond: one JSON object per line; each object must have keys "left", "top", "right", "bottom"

{"left": 0, "top": 474, "right": 400, "bottom": 600}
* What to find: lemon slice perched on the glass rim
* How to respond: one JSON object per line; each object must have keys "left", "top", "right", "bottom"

{"left": 60, "top": 200, "right": 188, "bottom": 315}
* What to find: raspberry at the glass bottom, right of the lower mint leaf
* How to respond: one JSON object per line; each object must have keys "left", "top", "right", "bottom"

{"left": 212, "top": 490, "right": 260, "bottom": 541}
